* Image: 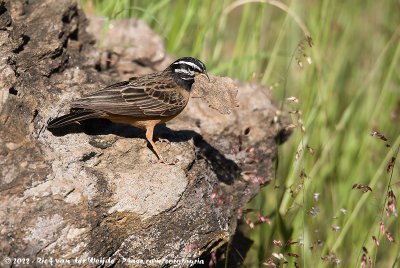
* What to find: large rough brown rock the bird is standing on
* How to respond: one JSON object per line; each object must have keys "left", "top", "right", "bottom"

{"left": 0, "top": 0, "right": 285, "bottom": 266}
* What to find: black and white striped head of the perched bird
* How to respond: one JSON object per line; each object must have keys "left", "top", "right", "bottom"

{"left": 168, "top": 57, "right": 210, "bottom": 91}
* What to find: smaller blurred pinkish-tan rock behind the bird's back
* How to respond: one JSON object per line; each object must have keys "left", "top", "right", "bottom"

{"left": 86, "top": 15, "right": 175, "bottom": 79}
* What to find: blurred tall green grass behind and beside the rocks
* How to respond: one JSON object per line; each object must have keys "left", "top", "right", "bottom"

{"left": 81, "top": 0, "right": 400, "bottom": 267}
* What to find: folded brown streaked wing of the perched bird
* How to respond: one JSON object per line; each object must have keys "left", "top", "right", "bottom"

{"left": 72, "top": 72, "right": 188, "bottom": 118}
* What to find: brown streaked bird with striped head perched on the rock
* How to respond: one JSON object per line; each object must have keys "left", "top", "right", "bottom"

{"left": 47, "top": 57, "right": 210, "bottom": 163}
